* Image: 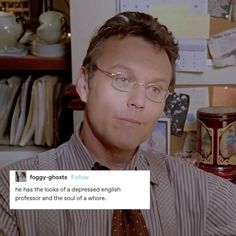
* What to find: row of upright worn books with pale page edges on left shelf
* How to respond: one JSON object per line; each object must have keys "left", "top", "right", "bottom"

{"left": 0, "top": 75, "right": 63, "bottom": 146}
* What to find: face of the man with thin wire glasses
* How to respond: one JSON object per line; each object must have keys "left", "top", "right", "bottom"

{"left": 77, "top": 36, "right": 171, "bottom": 151}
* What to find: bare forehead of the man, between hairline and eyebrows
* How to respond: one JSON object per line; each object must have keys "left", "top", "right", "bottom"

{"left": 98, "top": 36, "right": 172, "bottom": 82}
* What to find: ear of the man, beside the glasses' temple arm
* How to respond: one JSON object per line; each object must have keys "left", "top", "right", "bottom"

{"left": 76, "top": 67, "right": 89, "bottom": 103}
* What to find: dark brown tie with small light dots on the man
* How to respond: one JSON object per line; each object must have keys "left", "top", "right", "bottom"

{"left": 92, "top": 162, "right": 149, "bottom": 236}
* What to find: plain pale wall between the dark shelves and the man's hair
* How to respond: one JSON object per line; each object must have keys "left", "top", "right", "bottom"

{"left": 70, "top": 0, "right": 116, "bottom": 126}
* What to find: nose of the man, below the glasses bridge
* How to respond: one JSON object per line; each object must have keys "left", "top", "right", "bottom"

{"left": 128, "top": 83, "right": 146, "bottom": 110}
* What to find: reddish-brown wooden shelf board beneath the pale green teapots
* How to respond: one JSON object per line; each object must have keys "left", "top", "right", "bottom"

{"left": 0, "top": 55, "right": 71, "bottom": 71}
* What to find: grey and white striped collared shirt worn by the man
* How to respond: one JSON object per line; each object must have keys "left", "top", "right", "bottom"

{"left": 0, "top": 131, "right": 236, "bottom": 236}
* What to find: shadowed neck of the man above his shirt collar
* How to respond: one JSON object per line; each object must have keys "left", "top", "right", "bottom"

{"left": 80, "top": 123, "right": 136, "bottom": 170}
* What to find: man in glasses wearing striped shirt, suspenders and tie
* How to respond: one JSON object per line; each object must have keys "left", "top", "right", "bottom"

{"left": 0, "top": 12, "right": 236, "bottom": 236}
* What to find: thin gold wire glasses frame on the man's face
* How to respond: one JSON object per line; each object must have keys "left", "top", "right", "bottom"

{"left": 92, "top": 64, "right": 172, "bottom": 103}
